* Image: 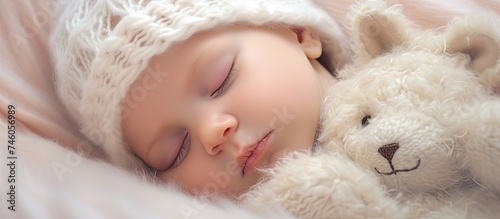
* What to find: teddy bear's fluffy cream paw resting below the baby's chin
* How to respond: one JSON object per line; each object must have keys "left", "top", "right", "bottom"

{"left": 241, "top": 154, "right": 408, "bottom": 218}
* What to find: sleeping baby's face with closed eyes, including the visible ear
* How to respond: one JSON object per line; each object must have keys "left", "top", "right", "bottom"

{"left": 123, "top": 26, "right": 334, "bottom": 196}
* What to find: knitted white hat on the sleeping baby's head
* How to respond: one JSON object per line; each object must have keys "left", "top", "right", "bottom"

{"left": 51, "top": 0, "right": 346, "bottom": 168}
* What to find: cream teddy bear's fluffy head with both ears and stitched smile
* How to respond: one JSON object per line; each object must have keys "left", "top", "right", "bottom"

{"left": 319, "top": 1, "right": 500, "bottom": 191}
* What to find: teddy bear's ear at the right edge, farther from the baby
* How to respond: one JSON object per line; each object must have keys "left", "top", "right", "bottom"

{"left": 444, "top": 13, "right": 500, "bottom": 74}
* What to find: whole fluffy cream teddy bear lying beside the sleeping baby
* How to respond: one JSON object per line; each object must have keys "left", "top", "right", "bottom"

{"left": 241, "top": 0, "right": 500, "bottom": 218}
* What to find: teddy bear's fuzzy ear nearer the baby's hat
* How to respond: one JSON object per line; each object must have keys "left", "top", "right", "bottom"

{"left": 350, "top": 0, "right": 413, "bottom": 61}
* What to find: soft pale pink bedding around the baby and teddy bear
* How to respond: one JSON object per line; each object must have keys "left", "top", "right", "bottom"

{"left": 0, "top": 0, "right": 500, "bottom": 218}
